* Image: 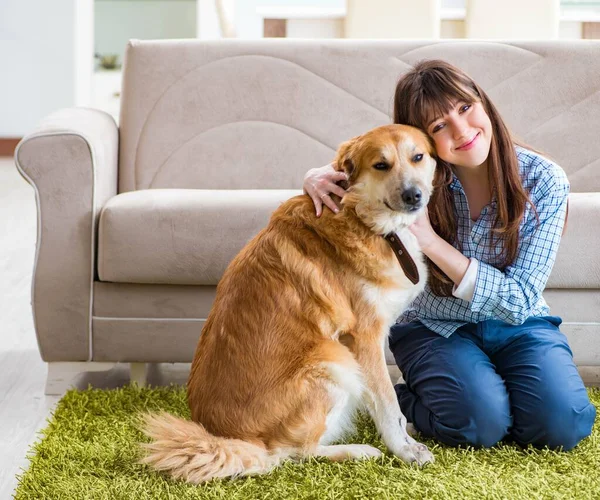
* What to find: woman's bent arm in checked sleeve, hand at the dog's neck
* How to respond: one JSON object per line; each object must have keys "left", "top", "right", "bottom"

{"left": 411, "top": 160, "right": 569, "bottom": 324}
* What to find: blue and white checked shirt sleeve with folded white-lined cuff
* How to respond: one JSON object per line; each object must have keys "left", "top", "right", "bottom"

{"left": 470, "top": 160, "right": 569, "bottom": 325}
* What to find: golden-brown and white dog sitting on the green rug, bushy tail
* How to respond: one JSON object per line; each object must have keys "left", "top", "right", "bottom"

{"left": 142, "top": 125, "right": 435, "bottom": 483}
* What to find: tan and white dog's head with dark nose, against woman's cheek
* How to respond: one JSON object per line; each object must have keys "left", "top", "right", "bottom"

{"left": 334, "top": 125, "right": 436, "bottom": 234}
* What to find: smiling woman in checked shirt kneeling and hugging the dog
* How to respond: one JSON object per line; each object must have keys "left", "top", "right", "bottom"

{"left": 304, "top": 60, "right": 596, "bottom": 450}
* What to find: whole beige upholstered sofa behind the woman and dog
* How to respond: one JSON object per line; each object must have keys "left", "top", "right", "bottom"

{"left": 16, "top": 40, "right": 600, "bottom": 393}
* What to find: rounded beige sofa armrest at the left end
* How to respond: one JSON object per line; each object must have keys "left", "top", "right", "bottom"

{"left": 15, "top": 108, "right": 119, "bottom": 361}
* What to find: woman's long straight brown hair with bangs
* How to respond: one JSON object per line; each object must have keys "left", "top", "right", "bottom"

{"left": 394, "top": 60, "right": 537, "bottom": 297}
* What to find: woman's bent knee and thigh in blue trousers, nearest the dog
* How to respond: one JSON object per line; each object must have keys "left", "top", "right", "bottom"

{"left": 394, "top": 325, "right": 512, "bottom": 447}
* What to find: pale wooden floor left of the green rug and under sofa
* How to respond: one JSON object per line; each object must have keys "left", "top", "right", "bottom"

{"left": 0, "top": 158, "right": 600, "bottom": 499}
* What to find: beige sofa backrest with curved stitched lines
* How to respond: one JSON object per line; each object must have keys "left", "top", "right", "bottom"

{"left": 119, "top": 39, "right": 600, "bottom": 192}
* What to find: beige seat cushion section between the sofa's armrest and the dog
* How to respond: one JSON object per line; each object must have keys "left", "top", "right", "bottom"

{"left": 98, "top": 189, "right": 302, "bottom": 285}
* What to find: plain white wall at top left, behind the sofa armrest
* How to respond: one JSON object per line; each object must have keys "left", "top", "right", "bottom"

{"left": 0, "top": 0, "right": 93, "bottom": 137}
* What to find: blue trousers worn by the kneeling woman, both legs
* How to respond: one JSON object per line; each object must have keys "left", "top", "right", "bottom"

{"left": 390, "top": 316, "right": 596, "bottom": 450}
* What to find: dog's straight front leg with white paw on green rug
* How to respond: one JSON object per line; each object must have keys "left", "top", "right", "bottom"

{"left": 353, "top": 335, "right": 434, "bottom": 465}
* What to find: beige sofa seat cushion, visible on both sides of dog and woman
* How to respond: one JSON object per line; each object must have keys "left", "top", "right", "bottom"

{"left": 98, "top": 189, "right": 600, "bottom": 288}
